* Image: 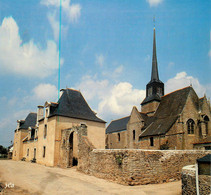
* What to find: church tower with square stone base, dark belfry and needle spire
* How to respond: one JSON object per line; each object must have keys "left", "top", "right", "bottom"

{"left": 141, "top": 28, "right": 164, "bottom": 115}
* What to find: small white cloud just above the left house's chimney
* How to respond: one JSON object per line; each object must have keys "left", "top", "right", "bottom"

{"left": 33, "top": 83, "right": 57, "bottom": 101}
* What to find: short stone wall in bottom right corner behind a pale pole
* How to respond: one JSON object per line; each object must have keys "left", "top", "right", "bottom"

{"left": 182, "top": 165, "right": 211, "bottom": 195}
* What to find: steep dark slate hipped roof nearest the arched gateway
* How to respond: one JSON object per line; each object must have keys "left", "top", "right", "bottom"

{"left": 49, "top": 89, "right": 106, "bottom": 123}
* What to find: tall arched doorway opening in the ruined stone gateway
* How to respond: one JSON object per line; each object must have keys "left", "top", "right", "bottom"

{"left": 69, "top": 131, "right": 78, "bottom": 167}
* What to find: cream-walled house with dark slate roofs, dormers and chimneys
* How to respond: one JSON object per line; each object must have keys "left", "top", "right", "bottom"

{"left": 13, "top": 89, "right": 106, "bottom": 167}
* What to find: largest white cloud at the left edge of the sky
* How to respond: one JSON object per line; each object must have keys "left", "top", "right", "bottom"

{"left": 0, "top": 17, "right": 59, "bottom": 78}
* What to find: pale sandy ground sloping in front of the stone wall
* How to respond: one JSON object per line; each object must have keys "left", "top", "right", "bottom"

{"left": 0, "top": 160, "right": 181, "bottom": 195}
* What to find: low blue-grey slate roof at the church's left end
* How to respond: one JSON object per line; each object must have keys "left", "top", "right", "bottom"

{"left": 106, "top": 116, "right": 130, "bottom": 134}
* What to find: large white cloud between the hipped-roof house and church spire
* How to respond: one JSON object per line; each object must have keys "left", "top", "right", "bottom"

{"left": 75, "top": 76, "right": 145, "bottom": 120}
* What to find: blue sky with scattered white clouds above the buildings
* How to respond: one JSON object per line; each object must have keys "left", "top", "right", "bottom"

{"left": 0, "top": 0, "right": 211, "bottom": 146}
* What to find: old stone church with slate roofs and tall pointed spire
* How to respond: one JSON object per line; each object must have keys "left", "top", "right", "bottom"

{"left": 106, "top": 28, "right": 211, "bottom": 150}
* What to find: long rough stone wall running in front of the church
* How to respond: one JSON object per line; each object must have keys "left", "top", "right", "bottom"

{"left": 80, "top": 149, "right": 211, "bottom": 185}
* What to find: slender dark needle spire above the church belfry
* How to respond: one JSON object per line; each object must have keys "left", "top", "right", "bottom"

{"left": 151, "top": 27, "right": 159, "bottom": 82}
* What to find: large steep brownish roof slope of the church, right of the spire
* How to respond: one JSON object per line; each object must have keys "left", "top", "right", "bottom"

{"left": 139, "top": 87, "right": 197, "bottom": 137}
